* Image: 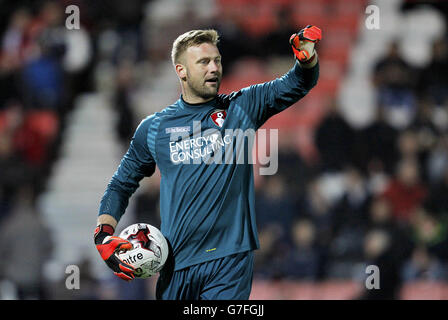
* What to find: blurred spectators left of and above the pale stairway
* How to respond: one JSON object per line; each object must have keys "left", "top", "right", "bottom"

{"left": 0, "top": 0, "right": 148, "bottom": 299}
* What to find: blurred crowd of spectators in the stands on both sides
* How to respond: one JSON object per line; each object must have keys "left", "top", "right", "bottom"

{"left": 0, "top": 0, "right": 448, "bottom": 299}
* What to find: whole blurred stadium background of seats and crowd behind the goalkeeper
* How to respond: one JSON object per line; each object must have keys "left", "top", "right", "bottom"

{"left": 0, "top": 0, "right": 448, "bottom": 299}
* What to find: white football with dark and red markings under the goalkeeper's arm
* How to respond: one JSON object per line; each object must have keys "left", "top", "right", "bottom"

{"left": 116, "top": 223, "right": 169, "bottom": 279}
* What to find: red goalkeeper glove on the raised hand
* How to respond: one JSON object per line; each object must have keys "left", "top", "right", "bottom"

{"left": 289, "top": 25, "right": 322, "bottom": 63}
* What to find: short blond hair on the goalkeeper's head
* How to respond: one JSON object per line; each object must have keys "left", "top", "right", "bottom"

{"left": 171, "top": 29, "right": 219, "bottom": 65}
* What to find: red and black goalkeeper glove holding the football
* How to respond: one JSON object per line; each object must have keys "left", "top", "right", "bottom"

{"left": 94, "top": 224, "right": 134, "bottom": 281}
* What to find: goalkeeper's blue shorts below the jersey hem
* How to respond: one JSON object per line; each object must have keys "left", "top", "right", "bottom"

{"left": 156, "top": 251, "right": 254, "bottom": 300}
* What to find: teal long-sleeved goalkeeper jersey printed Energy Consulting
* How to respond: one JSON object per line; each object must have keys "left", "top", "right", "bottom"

{"left": 99, "top": 62, "right": 319, "bottom": 270}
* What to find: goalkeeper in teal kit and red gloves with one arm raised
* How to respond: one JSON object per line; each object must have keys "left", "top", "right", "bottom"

{"left": 94, "top": 26, "right": 321, "bottom": 300}
